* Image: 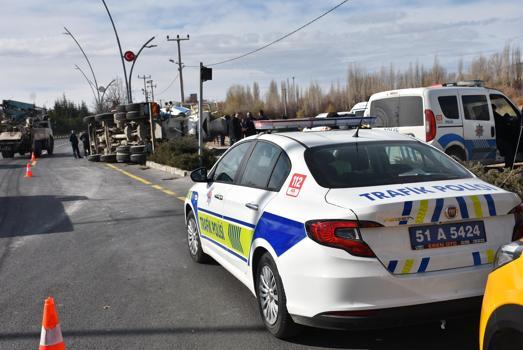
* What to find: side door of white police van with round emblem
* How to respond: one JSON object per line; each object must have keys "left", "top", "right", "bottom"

{"left": 459, "top": 88, "right": 496, "bottom": 160}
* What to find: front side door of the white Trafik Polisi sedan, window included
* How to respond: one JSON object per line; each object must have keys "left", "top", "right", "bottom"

{"left": 196, "top": 141, "right": 254, "bottom": 263}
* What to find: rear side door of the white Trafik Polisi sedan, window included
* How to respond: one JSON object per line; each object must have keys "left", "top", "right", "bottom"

{"left": 223, "top": 140, "right": 290, "bottom": 273}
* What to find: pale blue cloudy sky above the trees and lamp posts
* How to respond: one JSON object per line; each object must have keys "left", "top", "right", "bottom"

{"left": 0, "top": 0, "right": 523, "bottom": 107}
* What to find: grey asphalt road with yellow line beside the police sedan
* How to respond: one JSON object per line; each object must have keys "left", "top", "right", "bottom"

{"left": 0, "top": 141, "right": 478, "bottom": 350}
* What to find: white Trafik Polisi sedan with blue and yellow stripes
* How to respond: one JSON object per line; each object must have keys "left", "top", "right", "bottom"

{"left": 185, "top": 118, "right": 521, "bottom": 338}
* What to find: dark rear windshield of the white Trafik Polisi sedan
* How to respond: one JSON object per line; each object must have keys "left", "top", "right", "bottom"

{"left": 305, "top": 141, "right": 472, "bottom": 188}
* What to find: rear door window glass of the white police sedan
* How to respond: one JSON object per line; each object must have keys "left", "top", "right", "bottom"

{"left": 240, "top": 141, "right": 281, "bottom": 188}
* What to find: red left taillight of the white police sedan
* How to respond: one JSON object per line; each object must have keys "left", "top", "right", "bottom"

{"left": 305, "top": 220, "right": 381, "bottom": 257}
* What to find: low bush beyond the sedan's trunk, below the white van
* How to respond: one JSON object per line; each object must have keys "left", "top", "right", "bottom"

{"left": 464, "top": 162, "right": 523, "bottom": 198}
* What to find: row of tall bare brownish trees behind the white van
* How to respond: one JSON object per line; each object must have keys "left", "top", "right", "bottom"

{"left": 221, "top": 44, "right": 523, "bottom": 117}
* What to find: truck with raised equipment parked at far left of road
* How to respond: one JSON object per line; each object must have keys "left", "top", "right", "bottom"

{"left": 0, "top": 100, "right": 54, "bottom": 158}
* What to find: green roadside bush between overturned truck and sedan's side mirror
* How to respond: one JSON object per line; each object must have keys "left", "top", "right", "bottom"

{"left": 148, "top": 136, "right": 216, "bottom": 170}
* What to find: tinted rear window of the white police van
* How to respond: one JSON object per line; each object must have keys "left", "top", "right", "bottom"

{"left": 370, "top": 96, "right": 423, "bottom": 128}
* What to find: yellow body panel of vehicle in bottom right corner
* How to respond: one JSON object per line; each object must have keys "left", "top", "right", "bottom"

{"left": 479, "top": 249, "right": 523, "bottom": 350}
